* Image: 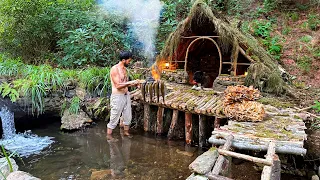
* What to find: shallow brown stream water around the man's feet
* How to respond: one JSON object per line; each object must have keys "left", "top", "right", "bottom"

{"left": 17, "top": 122, "right": 200, "bottom": 180}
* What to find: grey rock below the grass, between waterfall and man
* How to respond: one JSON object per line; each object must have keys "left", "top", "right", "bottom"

{"left": 60, "top": 110, "right": 92, "bottom": 130}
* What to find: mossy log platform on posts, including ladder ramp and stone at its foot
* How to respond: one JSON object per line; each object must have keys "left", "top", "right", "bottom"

{"left": 131, "top": 83, "right": 307, "bottom": 180}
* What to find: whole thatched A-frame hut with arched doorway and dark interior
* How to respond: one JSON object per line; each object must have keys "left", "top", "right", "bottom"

{"left": 157, "top": 0, "right": 285, "bottom": 93}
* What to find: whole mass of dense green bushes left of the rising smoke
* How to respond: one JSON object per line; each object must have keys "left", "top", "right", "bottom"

{"left": 0, "top": 0, "right": 130, "bottom": 67}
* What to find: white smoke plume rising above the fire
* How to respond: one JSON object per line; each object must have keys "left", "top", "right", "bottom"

{"left": 101, "top": 0, "right": 162, "bottom": 63}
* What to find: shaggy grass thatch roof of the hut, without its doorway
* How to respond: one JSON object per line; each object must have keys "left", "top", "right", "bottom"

{"left": 157, "top": 0, "right": 285, "bottom": 93}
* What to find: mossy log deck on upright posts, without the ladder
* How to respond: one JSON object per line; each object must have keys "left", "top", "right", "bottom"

{"left": 131, "top": 83, "right": 307, "bottom": 155}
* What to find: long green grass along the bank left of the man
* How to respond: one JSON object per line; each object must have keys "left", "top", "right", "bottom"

{"left": 0, "top": 54, "right": 112, "bottom": 115}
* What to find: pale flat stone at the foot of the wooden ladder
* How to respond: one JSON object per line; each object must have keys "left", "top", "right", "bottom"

{"left": 189, "top": 149, "right": 219, "bottom": 174}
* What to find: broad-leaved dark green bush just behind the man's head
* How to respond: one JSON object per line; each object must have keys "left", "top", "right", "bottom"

{"left": 57, "top": 15, "right": 130, "bottom": 67}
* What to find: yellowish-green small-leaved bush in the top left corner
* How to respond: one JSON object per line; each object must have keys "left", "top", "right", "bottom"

{"left": 0, "top": 0, "right": 94, "bottom": 63}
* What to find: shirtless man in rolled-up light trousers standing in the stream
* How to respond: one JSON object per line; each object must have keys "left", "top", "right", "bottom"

{"left": 107, "top": 51, "right": 137, "bottom": 140}
